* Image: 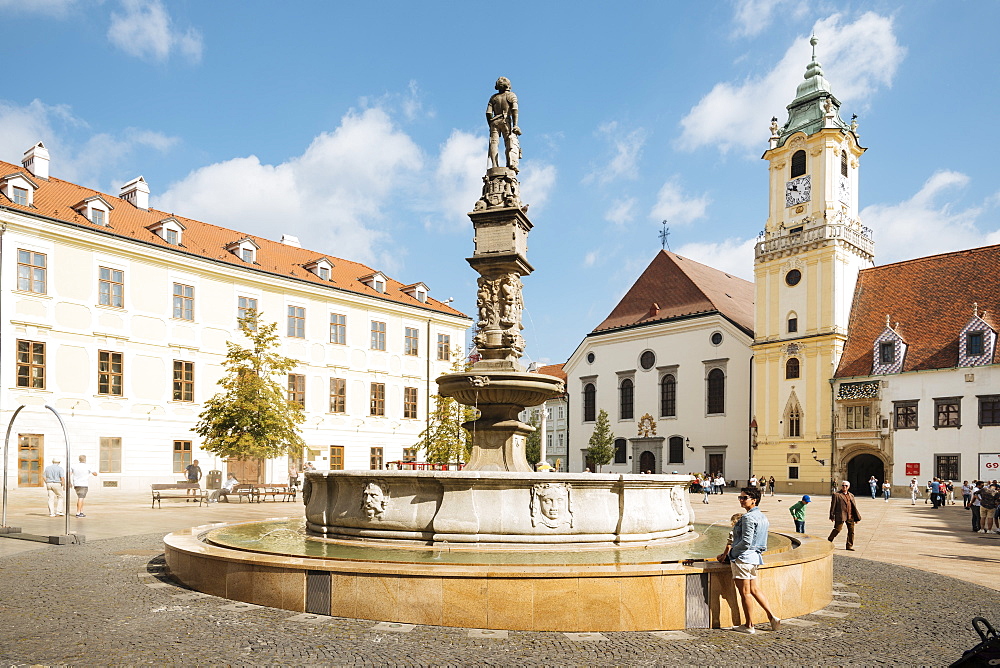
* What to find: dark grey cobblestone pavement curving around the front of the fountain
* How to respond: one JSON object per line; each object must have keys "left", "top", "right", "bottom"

{"left": 0, "top": 532, "right": 1000, "bottom": 666}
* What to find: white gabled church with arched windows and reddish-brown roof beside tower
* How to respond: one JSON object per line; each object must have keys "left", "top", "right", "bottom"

{"left": 565, "top": 251, "right": 753, "bottom": 481}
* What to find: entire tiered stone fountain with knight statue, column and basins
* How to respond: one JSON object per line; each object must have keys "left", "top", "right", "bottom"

{"left": 164, "top": 77, "right": 832, "bottom": 631}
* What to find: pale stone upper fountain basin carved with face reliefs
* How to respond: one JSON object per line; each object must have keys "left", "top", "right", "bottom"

{"left": 303, "top": 471, "right": 693, "bottom": 549}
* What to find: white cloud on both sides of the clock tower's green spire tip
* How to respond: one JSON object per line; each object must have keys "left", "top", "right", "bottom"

{"left": 678, "top": 12, "right": 906, "bottom": 153}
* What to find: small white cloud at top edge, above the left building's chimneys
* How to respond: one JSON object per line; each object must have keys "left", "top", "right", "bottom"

{"left": 108, "top": 0, "right": 202, "bottom": 63}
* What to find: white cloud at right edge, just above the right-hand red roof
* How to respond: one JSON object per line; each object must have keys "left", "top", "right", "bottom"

{"left": 861, "top": 171, "right": 1000, "bottom": 264}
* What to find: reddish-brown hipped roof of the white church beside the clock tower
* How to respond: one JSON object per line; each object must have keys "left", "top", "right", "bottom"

{"left": 592, "top": 250, "right": 754, "bottom": 336}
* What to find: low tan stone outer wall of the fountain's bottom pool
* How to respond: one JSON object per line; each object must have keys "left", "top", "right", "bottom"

{"left": 164, "top": 523, "right": 833, "bottom": 632}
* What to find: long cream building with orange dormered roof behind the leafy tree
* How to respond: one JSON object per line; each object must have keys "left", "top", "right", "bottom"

{"left": 0, "top": 144, "right": 470, "bottom": 490}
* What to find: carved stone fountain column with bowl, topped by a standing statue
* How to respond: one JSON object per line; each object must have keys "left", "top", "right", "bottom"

{"left": 437, "top": 77, "right": 563, "bottom": 472}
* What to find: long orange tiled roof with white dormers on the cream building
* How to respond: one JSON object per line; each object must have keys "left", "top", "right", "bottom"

{"left": 0, "top": 161, "right": 468, "bottom": 317}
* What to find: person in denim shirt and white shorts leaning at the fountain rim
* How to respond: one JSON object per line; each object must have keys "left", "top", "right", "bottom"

{"left": 716, "top": 487, "right": 781, "bottom": 633}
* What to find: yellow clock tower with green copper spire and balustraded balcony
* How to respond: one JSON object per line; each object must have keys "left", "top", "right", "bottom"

{"left": 752, "top": 36, "right": 875, "bottom": 494}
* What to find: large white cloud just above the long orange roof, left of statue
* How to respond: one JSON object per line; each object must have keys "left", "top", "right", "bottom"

{"left": 154, "top": 109, "right": 422, "bottom": 271}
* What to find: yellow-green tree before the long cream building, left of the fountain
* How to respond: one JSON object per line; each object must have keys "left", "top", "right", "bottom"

{"left": 195, "top": 311, "right": 305, "bottom": 460}
